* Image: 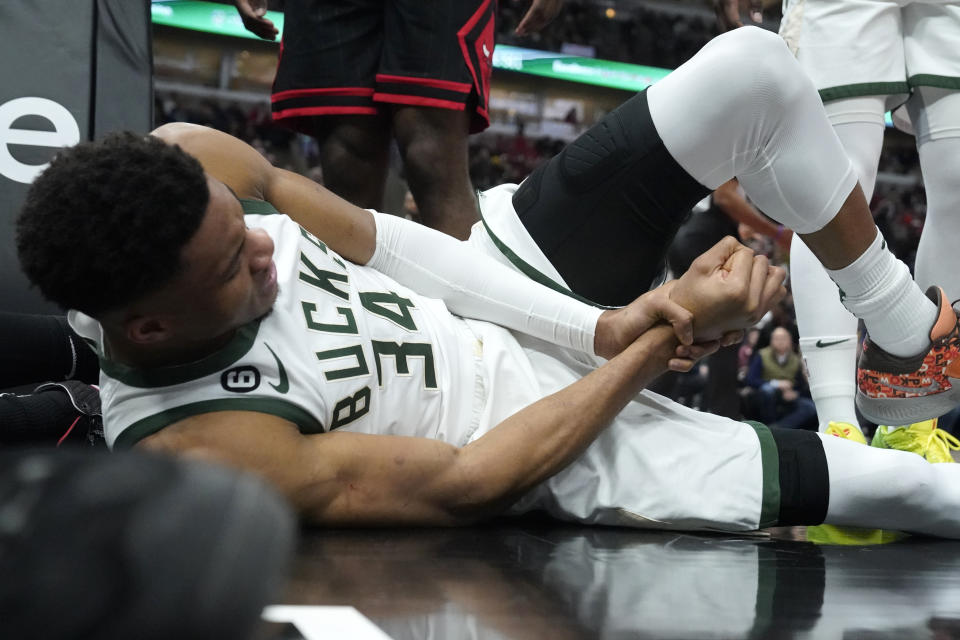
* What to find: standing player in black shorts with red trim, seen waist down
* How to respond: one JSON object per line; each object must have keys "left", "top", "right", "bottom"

{"left": 234, "top": 0, "right": 562, "bottom": 239}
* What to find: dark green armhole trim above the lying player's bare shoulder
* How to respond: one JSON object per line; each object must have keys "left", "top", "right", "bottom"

{"left": 113, "top": 398, "right": 323, "bottom": 450}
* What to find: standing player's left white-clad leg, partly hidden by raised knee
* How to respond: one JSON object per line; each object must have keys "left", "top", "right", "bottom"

{"left": 790, "top": 96, "right": 885, "bottom": 437}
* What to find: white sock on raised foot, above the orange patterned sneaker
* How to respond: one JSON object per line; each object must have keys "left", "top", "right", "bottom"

{"left": 827, "top": 229, "right": 939, "bottom": 356}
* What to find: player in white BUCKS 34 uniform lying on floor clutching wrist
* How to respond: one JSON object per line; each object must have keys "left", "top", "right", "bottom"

{"left": 18, "top": 28, "right": 960, "bottom": 537}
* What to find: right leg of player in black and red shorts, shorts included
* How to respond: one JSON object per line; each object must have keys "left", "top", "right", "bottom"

{"left": 374, "top": 0, "right": 496, "bottom": 239}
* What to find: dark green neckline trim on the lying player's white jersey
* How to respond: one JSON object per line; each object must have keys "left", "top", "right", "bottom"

{"left": 100, "top": 319, "right": 260, "bottom": 389}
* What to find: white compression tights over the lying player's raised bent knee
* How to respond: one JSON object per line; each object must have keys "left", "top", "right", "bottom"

{"left": 648, "top": 27, "right": 857, "bottom": 233}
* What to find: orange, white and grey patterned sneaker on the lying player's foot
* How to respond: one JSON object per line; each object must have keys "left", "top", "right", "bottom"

{"left": 857, "top": 287, "right": 960, "bottom": 424}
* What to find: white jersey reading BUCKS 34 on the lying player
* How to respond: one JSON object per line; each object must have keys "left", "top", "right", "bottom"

{"left": 70, "top": 201, "right": 484, "bottom": 447}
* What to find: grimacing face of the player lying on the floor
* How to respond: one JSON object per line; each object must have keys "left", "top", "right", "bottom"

{"left": 169, "top": 177, "right": 278, "bottom": 340}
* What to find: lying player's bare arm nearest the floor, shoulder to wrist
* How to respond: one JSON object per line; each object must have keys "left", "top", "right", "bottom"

{"left": 138, "top": 326, "right": 677, "bottom": 526}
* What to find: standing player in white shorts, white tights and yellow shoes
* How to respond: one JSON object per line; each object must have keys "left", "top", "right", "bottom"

{"left": 716, "top": 0, "right": 960, "bottom": 462}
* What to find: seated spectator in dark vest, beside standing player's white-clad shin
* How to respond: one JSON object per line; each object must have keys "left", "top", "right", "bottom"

{"left": 746, "top": 327, "right": 817, "bottom": 429}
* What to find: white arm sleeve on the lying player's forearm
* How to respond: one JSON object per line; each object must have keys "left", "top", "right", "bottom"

{"left": 367, "top": 212, "right": 603, "bottom": 355}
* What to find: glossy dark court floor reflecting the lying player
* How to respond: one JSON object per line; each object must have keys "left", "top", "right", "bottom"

{"left": 262, "top": 521, "right": 960, "bottom": 640}
